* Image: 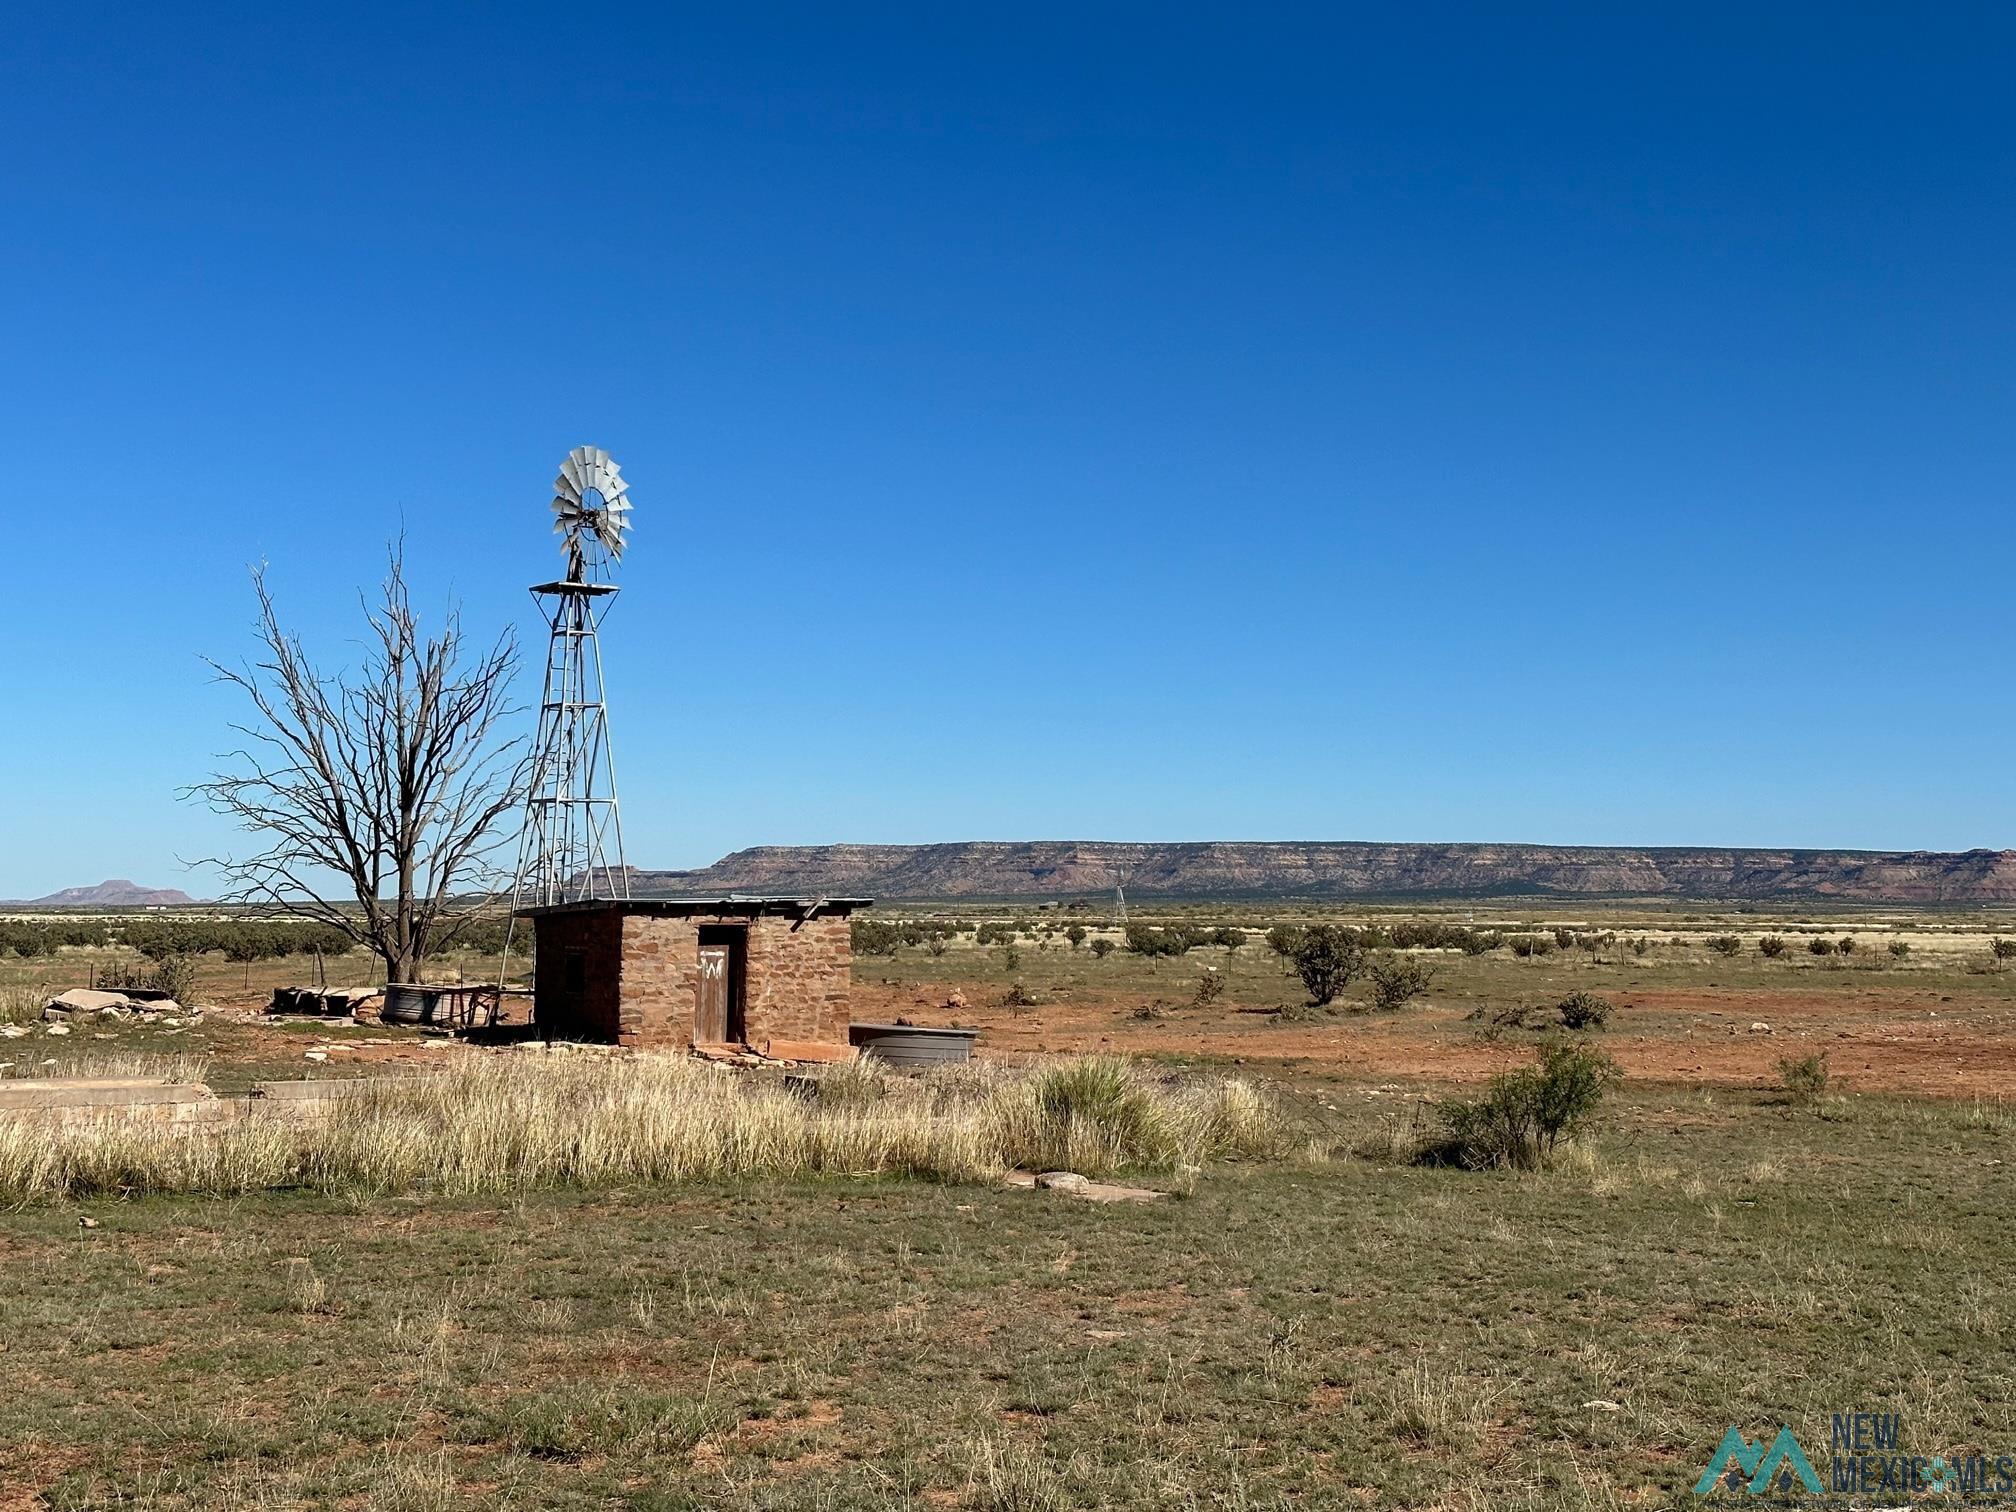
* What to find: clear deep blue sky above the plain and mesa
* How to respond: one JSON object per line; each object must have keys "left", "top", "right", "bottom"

{"left": 0, "top": 4, "right": 2016, "bottom": 895}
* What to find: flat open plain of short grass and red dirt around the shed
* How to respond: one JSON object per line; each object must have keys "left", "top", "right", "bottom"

{"left": 0, "top": 905, "right": 2016, "bottom": 1508}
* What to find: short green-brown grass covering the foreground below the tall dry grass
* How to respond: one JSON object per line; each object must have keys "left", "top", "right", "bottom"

{"left": 0, "top": 1091, "right": 2016, "bottom": 1508}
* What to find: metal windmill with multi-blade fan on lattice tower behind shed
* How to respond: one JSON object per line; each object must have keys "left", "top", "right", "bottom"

{"left": 512, "top": 446, "right": 631, "bottom": 909}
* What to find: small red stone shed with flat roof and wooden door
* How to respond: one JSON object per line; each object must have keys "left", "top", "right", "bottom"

{"left": 524, "top": 897, "right": 869, "bottom": 1060}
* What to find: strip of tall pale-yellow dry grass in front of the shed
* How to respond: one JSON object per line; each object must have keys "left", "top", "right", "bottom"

{"left": 0, "top": 1056, "right": 1292, "bottom": 1200}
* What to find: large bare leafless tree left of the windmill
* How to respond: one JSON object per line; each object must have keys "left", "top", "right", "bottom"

{"left": 190, "top": 542, "right": 526, "bottom": 982}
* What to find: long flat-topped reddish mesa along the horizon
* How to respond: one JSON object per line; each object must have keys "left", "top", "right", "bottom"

{"left": 633, "top": 841, "right": 2016, "bottom": 903}
